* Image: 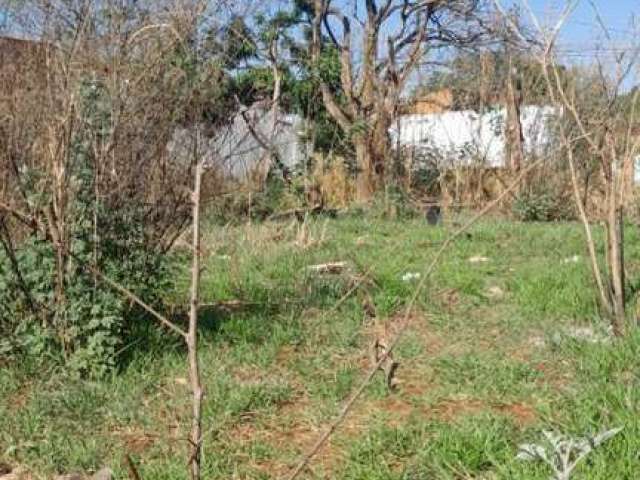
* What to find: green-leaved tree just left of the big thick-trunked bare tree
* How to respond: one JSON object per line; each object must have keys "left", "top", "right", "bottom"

{"left": 216, "top": 0, "right": 351, "bottom": 180}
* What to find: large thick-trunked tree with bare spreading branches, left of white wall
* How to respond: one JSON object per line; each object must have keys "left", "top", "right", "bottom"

{"left": 310, "top": 0, "right": 482, "bottom": 201}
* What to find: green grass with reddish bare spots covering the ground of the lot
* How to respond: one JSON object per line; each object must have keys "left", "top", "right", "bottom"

{"left": 0, "top": 216, "right": 640, "bottom": 480}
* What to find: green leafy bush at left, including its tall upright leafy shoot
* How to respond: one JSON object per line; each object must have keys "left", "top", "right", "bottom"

{"left": 0, "top": 80, "right": 171, "bottom": 375}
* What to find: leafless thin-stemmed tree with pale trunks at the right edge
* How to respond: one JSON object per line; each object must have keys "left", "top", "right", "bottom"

{"left": 494, "top": 0, "right": 640, "bottom": 335}
